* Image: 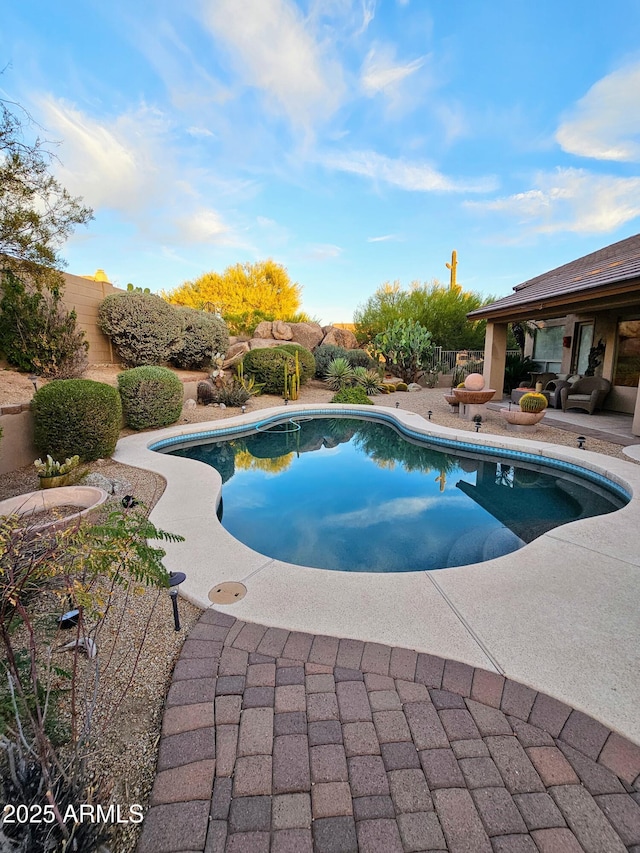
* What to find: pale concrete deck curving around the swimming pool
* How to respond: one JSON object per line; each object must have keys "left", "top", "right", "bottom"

{"left": 114, "top": 405, "right": 640, "bottom": 743}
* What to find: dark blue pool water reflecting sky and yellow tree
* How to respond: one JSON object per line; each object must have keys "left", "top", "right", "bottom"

{"left": 169, "top": 417, "right": 626, "bottom": 572}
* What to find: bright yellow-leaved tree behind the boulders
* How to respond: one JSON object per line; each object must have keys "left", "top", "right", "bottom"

{"left": 161, "top": 258, "right": 302, "bottom": 334}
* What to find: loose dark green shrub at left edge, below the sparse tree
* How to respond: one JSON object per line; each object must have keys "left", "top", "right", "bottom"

{"left": 0, "top": 271, "right": 89, "bottom": 379}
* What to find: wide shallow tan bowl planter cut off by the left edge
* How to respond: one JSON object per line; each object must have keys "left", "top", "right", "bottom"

{"left": 0, "top": 486, "right": 109, "bottom": 533}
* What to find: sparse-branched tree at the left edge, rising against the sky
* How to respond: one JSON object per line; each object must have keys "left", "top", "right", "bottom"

{"left": 0, "top": 100, "right": 93, "bottom": 289}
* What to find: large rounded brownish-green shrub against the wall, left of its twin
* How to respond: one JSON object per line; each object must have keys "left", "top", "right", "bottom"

{"left": 98, "top": 291, "right": 182, "bottom": 367}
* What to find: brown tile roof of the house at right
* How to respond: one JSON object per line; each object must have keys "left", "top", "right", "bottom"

{"left": 468, "top": 234, "right": 640, "bottom": 317}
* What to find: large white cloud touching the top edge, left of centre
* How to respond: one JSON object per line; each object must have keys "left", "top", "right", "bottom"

{"left": 204, "top": 0, "right": 343, "bottom": 128}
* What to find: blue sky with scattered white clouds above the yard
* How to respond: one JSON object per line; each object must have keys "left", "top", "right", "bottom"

{"left": 0, "top": 0, "right": 640, "bottom": 323}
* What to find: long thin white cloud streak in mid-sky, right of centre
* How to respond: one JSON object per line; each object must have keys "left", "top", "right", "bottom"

{"left": 322, "top": 151, "right": 496, "bottom": 192}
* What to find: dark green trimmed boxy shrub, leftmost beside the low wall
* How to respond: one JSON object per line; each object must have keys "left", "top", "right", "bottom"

{"left": 31, "top": 379, "right": 122, "bottom": 462}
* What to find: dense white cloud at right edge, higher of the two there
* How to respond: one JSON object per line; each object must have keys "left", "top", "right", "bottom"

{"left": 556, "top": 62, "right": 640, "bottom": 162}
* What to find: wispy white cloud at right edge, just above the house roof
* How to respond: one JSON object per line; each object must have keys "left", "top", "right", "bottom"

{"left": 466, "top": 169, "right": 640, "bottom": 234}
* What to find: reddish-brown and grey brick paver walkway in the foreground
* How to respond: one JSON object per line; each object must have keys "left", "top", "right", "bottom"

{"left": 138, "top": 610, "right": 640, "bottom": 853}
